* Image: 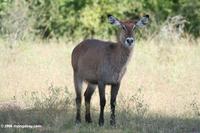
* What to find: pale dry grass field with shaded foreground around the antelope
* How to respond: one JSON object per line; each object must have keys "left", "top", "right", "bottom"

{"left": 0, "top": 40, "right": 200, "bottom": 133}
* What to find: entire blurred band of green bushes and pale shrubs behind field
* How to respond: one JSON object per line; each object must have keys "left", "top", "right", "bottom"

{"left": 0, "top": 0, "right": 200, "bottom": 40}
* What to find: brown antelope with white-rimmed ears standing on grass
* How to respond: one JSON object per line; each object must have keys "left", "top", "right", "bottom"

{"left": 72, "top": 15, "right": 149, "bottom": 126}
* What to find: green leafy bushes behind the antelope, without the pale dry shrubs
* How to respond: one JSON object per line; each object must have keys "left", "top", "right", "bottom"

{"left": 0, "top": 0, "right": 200, "bottom": 40}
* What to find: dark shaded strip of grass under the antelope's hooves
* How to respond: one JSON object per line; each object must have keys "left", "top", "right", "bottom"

{"left": 0, "top": 108, "right": 200, "bottom": 133}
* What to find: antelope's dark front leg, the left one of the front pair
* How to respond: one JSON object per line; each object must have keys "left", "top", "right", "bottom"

{"left": 98, "top": 82, "right": 106, "bottom": 126}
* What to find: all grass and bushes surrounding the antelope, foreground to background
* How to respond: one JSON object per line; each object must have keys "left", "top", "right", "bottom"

{"left": 0, "top": 0, "right": 200, "bottom": 133}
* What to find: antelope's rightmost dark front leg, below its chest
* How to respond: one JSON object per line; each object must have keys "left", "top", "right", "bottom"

{"left": 110, "top": 83, "right": 120, "bottom": 126}
